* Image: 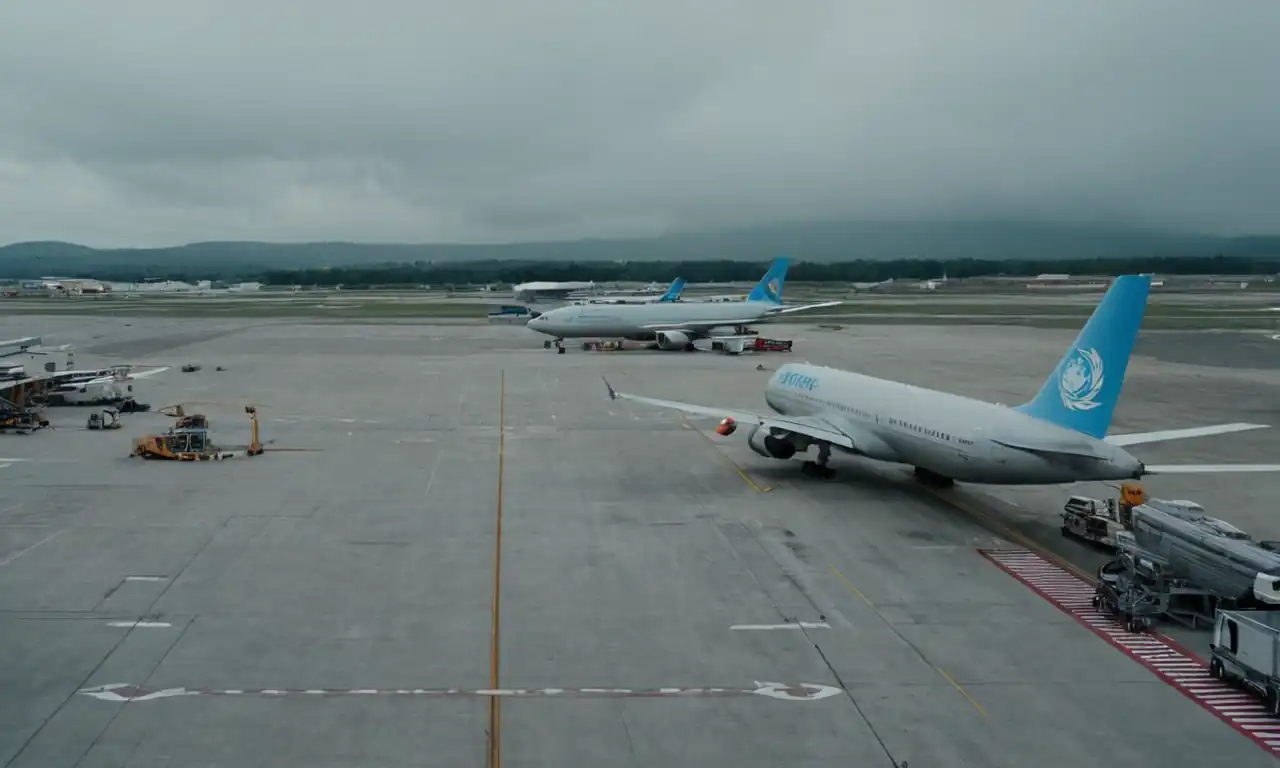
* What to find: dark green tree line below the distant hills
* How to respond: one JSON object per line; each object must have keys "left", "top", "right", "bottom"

{"left": 251, "top": 256, "right": 1280, "bottom": 288}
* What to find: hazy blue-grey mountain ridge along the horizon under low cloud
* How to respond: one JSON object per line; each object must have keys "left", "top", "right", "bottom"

{"left": 0, "top": 221, "right": 1280, "bottom": 279}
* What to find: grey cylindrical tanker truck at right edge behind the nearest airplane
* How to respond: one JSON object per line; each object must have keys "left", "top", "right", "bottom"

{"left": 1121, "top": 499, "right": 1280, "bottom": 608}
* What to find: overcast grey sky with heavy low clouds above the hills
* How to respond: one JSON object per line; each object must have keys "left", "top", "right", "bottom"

{"left": 0, "top": 0, "right": 1280, "bottom": 246}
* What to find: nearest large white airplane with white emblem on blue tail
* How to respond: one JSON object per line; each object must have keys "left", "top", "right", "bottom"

{"left": 604, "top": 275, "right": 1280, "bottom": 486}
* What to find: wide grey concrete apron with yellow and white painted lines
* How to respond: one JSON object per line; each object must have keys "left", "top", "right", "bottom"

{"left": 0, "top": 317, "right": 1280, "bottom": 768}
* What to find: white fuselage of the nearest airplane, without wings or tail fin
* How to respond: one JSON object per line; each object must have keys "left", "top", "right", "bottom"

{"left": 764, "top": 364, "right": 1142, "bottom": 485}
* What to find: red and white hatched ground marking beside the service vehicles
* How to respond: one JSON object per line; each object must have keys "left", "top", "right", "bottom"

{"left": 978, "top": 549, "right": 1280, "bottom": 755}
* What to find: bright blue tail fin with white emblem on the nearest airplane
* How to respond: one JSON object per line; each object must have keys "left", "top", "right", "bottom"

{"left": 1016, "top": 275, "right": 1151, "bottom": 439}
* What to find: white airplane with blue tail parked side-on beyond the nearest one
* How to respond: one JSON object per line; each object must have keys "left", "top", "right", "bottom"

{"left": 527, "top": 257, "right": 841, "bottom": 349}
